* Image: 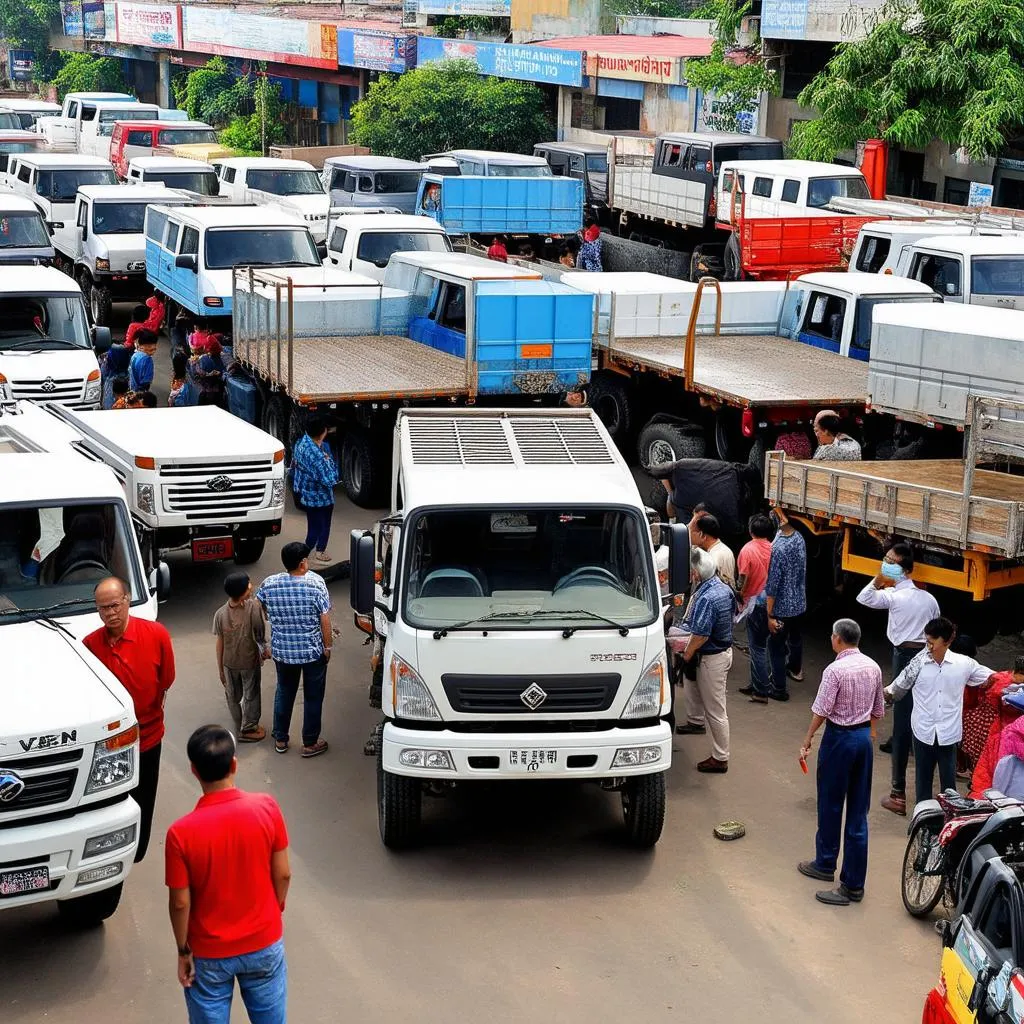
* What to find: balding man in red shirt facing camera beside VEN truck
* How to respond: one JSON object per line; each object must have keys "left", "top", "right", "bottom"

{"left": 82, "top": 577, "right": 174, "bottom": 864}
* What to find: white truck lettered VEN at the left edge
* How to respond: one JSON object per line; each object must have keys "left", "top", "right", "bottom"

{"left": 0, "top": 391, "right": 167, "bottom": 927}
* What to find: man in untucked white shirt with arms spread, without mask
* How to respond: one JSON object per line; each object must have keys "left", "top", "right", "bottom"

{"left": 885, "top": 618, "right": 992, "bottom": 804}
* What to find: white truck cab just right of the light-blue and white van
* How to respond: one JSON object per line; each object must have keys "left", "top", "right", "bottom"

{"left": 327, "top": 213, "right": 452, "bottom": 282}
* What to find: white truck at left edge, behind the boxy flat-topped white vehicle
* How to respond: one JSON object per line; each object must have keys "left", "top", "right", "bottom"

{"left": 0, "top": 266, "right": 111, "bottom": 410}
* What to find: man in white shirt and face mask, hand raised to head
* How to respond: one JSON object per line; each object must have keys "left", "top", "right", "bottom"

{"left": 857, "top": 543, "right": 939, "bottom": 815}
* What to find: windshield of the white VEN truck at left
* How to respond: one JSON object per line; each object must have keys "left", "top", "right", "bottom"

{"left": 0, "top": 499, "right": 145, "bottom": 624}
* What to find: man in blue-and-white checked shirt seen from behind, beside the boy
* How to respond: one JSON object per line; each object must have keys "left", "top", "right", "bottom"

{"left": 256, "top": 541, "right": 331, "bottom": 758}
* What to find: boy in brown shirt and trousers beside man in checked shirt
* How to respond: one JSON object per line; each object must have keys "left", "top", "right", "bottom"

{"left": 213, "top": 572, "right": 266, "bottom": 743}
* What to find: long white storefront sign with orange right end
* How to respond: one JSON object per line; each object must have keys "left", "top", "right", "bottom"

{"left": 181, "top": 6, "right": 338, "bottom": 71}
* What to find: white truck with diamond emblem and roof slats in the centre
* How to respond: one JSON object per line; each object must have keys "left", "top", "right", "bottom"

{"left": 351, "top": 409, "right": 689, "bottom": 848}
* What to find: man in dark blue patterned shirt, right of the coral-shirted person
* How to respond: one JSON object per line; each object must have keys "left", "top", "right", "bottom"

{"left": 765, "top": 509, "right": 807, "bottom": 700}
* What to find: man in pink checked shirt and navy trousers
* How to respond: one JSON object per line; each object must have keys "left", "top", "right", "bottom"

{"left": 797, "top": 618, "right": 885, "bottom": 906}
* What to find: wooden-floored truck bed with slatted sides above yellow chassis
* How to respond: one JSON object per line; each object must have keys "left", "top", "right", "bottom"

{"left": 765, "top": 452, "right": 1024, "bottom": 558}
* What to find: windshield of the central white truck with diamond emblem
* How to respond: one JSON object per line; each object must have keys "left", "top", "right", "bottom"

{"left": 404, "top": 506, "right": 658, "bottom": 629}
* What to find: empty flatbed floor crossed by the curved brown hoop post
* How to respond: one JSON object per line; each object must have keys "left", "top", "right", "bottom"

{"left": 602, "top": 334, "right": 867, "bottom": 409}
